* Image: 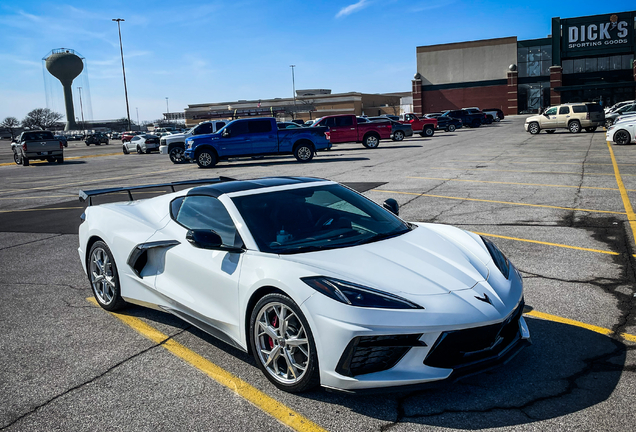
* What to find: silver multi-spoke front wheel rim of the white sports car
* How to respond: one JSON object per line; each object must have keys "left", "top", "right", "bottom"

{"left": 253, "top": 302, "right": 311, "bottom": 385}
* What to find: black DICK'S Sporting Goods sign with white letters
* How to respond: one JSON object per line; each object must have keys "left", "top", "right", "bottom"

{"left": 561, "top": 12, "right": 634, "bottom": 58}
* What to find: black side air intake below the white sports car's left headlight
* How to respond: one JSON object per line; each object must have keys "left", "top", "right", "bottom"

{"left": 336, "top": 334, "right": 425, "bottom": 377}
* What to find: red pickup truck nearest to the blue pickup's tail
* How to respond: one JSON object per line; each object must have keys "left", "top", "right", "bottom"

{"left": 311, "top": 114, "right": 391, "bottom": 148}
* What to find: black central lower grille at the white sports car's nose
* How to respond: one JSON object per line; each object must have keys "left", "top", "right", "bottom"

{"left": 424, "top": 301, "right": 524, "bottom": 369}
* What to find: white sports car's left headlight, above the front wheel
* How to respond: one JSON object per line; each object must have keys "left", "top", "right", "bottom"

{"left": 301, "top": 276, "right": 424, "bottom": 309}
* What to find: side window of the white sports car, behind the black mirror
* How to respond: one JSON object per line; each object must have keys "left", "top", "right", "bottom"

{"left": 171, "top": 195, "right": 242, "bottom": 246}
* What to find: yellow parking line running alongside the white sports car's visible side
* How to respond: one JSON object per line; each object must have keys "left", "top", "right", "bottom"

{"left": 86, "top": 297, "right": 326, "bottom": 432}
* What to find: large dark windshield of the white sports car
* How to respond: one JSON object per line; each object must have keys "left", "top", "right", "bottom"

{"left": 232, "top": 185, "right": 411, "bottom": 254}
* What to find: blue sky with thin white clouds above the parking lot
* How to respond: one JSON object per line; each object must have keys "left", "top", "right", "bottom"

{"left": 0, "top": 0, "right": 636, "bottom": 121}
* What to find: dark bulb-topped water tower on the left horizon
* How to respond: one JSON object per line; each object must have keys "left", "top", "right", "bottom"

{"left": 46, "top": 48, "right": 84, "bottom": 131}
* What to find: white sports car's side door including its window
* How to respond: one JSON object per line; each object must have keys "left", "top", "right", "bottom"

{"left": 149, "top": 195, "right": 243, "bottom": 341}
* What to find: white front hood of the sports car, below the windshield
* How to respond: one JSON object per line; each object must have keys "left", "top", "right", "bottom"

{"left": 281, "top": 226, "right": 488, "bottom": 296}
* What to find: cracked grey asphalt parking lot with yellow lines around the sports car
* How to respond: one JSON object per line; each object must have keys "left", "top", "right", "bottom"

{"left": 0, "top": 116, "right": 636, "bottom": 432}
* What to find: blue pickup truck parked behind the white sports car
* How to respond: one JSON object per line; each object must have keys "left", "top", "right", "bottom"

{"left": 185, "top": 117, "right": 331, "bottom": 168}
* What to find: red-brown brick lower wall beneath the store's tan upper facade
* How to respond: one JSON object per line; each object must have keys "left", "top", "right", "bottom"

{"left": 422, "top": 85, "right": 517, "bottom": 115}
